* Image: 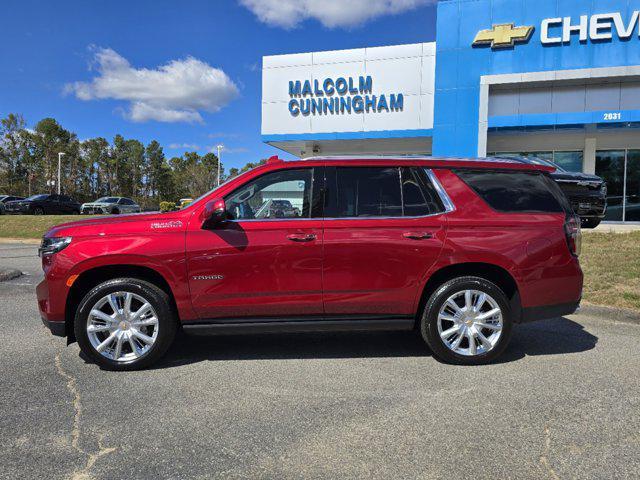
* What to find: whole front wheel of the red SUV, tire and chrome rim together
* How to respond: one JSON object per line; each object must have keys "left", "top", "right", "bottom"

{"left": 74, "top": 278, "right": 177, "bottom": 370}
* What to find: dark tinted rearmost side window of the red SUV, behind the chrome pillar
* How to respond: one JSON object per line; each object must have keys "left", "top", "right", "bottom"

{"left": 455, "top": 170, "right": 565, "bottom": 213}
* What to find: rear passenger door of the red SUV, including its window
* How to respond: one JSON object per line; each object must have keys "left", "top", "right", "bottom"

{"left": 323, "top": 166, "right": 448, "bottom": 317}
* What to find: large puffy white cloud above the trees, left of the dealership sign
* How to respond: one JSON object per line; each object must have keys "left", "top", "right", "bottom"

{"left": 65, "top": 48, "right": 238, "bottom": 123}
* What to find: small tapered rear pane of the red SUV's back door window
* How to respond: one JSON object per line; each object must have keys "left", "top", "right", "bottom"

{"left": 401, "top": 167, "right": 445, "bottom": 217}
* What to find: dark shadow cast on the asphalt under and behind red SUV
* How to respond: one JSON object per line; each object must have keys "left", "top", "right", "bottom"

{"left": 144, "top": 318, "right": 598, "bottom": 369}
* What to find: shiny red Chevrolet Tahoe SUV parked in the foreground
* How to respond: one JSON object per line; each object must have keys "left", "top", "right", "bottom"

{"left": 37, "top": 158, "right": 582, "bottom": 370}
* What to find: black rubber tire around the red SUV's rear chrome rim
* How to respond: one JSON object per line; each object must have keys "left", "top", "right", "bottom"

{"left": 420, "top": 277, "right": 513, "bottom": 365}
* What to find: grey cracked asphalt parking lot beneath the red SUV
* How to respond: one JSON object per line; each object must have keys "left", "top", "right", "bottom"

{"left": 0, "top": 244, "right": 640, "bottom": 479}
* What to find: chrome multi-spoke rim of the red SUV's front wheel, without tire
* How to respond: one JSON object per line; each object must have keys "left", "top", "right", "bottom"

{"left": 87, "top": 292, "right": 158, "bottom": 363}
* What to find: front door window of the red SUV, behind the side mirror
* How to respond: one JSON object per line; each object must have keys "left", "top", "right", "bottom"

{"left": 225, "top": 168, "right": 313, "bottom": 220}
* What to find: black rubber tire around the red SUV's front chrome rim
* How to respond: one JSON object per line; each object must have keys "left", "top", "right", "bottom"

{"left": 74, "top": 278, "right": 178, "bottom": 371}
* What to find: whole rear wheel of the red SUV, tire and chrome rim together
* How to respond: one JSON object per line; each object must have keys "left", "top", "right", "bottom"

{"left": 420, "top": 277, "right": 512, "bottom": 365}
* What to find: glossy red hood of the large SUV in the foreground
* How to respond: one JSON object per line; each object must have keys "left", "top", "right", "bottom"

{"left": 45, "top": 211, "right": 190, "bottom": 237}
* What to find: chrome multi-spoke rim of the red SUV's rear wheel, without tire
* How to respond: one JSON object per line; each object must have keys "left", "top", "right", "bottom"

{"left": 438, "top": 290, "right": 503, "bottom": 357}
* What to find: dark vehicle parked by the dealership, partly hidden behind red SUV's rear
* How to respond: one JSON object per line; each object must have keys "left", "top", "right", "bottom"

{"left": 502, "top": 155, "right": 607, "bottom": 228}
